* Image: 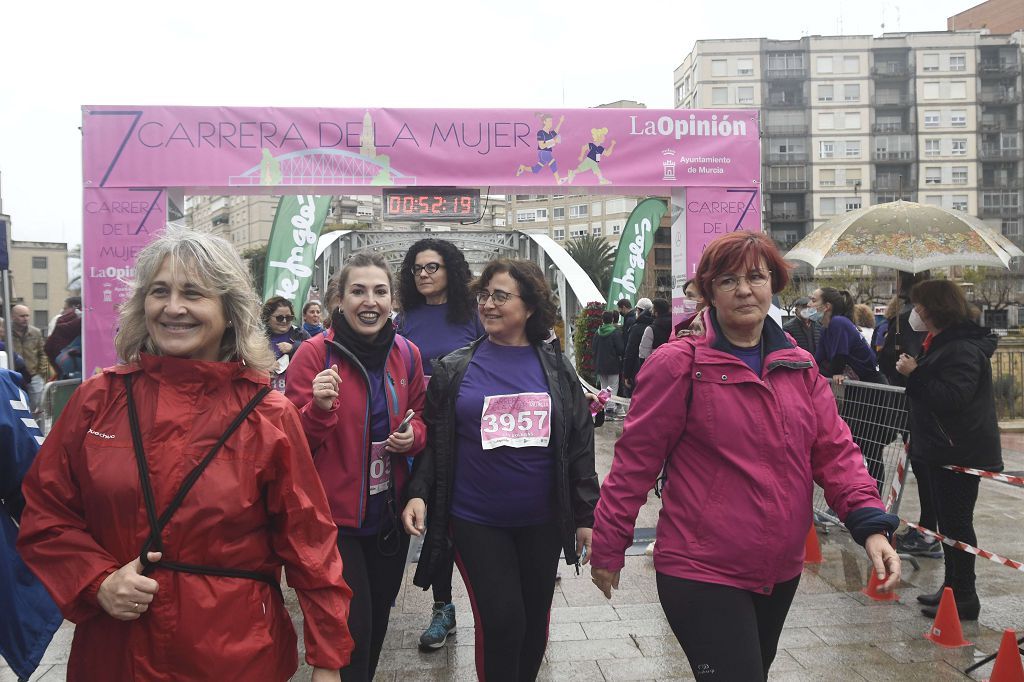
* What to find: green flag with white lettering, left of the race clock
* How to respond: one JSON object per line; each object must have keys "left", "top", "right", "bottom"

{"left": 263, "top": 195, "right": 331, "bottom": 315}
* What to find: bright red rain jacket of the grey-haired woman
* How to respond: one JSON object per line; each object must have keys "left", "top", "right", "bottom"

{"left": 18, "top": 355, "right": 352, "bottom": 682}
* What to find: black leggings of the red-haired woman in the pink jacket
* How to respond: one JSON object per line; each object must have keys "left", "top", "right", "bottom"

{"left": 657, "top": 572, "right": 800, "bottom": 682}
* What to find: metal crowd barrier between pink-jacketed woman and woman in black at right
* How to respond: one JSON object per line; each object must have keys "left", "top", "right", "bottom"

{"left": 814, "top": 379, "right": 909, "bottom": 529}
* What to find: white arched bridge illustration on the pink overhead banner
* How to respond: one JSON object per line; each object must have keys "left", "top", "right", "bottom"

{"left": 227, "top": 148, "right": 417, "bottom": 187}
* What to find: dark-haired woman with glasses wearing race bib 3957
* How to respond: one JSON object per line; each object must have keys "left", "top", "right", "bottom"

{"left": 402, "top": 260, "right": 598, "bottom": 682}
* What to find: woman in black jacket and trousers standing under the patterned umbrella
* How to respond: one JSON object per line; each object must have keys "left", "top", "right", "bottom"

{"left": 896, "top": 280, "right": 1002, "bottom": 621}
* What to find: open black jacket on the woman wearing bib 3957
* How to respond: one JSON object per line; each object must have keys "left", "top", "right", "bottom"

{"left": 406, "top": 339, "right": 599, "bottom": 590}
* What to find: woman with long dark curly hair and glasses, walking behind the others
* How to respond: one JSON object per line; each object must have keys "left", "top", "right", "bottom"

{"left": 395, "top": 239, "right": 483, "bottom": 651}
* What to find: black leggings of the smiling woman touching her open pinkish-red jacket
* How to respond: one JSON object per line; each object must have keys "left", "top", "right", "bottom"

{"left": 338, "top": 532, "right": 409, "bottom": 682}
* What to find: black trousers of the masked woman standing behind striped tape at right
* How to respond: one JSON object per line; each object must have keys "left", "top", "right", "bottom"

{"left": 919, "top": 463, "right": 981, "bottom": 599}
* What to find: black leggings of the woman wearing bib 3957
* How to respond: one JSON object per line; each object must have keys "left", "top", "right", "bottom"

{"left": 450, "top": 517, "right": 561, "bottom": 682}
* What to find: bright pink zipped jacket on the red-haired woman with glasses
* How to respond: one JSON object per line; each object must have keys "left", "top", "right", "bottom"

{"left": 592, "top": 311, "right": 884, "bottom": 594}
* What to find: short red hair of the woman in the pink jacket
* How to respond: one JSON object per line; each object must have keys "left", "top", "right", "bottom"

{"left": 693, "top": 230, "right": 793, "bottom": 301}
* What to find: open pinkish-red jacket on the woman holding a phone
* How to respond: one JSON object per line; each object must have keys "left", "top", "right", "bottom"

{"left": 285, "top": 330, "right": 427, "bottom": 528}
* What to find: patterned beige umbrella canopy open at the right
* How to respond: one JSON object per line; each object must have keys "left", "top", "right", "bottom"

{"left": 785, "top": 201, "right": 1024, "bottom": 272}
